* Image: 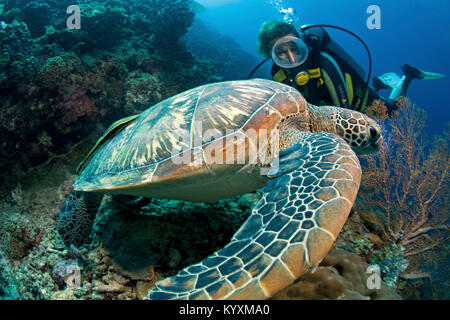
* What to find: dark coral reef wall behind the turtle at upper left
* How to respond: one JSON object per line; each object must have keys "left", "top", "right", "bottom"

{"left": 0, "top": 0, "right": 218, "bottom": 189}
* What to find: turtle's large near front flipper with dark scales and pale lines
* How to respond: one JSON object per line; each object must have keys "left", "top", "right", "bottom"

{"left": 147, "top": 132, "right": 361, "bottom": 299}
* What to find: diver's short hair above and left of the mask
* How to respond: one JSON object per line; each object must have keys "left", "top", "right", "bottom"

{"left": 258, "top": 20, "right": 300, "bottom": 58}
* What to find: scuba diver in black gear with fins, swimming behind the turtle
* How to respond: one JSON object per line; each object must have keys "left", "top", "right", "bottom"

{"left": 249, "top": 21, "right": 444, "bottom": 117}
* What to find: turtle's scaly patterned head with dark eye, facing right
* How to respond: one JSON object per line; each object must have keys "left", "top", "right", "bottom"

{"left": 308, "top": 105, "right": 383, "bottom": 155}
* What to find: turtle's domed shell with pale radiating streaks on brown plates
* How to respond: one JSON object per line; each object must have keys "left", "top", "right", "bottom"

{"left": 74, "top": 79, "right": 306, "bottom": 201}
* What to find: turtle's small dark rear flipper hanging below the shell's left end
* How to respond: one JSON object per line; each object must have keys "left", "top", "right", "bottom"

{"left": 57, "top": 191, "right": 103, "bottom": 246}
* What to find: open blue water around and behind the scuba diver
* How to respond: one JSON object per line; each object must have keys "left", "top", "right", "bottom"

{"left": 198, "top": 0, "right": 450, "bottom": 133}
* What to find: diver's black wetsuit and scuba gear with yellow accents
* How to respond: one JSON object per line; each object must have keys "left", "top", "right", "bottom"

{"left": 271, "top": 27, "right": 397, "bottom": 114}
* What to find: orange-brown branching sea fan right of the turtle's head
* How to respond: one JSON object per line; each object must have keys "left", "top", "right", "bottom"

{"left": 359, "top": 99, "right": 450, "bottom": 276}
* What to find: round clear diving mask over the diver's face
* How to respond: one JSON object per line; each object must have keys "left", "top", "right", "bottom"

{"left": 272, "top": 36, "right": 308, "bottom": 69}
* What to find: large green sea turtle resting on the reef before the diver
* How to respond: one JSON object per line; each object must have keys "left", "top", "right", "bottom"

{"left": 58, "top": 79, "right": 382, "bottom": 299}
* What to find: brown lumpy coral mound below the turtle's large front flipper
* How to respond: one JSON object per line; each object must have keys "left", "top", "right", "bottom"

{"left": 273, "top": 249, "right": 401, "bottom": 300}
